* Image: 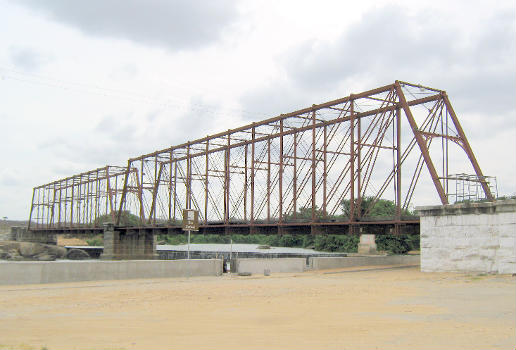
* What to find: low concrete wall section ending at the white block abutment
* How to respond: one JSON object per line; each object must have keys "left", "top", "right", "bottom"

{"left": 310, "top": 255, "right": 419, "bottom": 270}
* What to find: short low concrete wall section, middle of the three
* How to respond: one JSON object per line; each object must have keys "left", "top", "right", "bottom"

{"left": 236, "top": 258, "right": 306, "bottom": 274}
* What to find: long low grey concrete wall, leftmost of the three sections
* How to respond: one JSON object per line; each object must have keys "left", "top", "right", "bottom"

{"left": 0, "top": 259, "right": 222, "bottom": 285}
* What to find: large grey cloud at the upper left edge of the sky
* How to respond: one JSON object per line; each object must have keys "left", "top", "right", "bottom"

{"left": 12, "top": 0, "right": 236, "bottom": 50}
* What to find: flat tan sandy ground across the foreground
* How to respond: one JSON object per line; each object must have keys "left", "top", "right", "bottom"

{"left": 0, "top": 268, "right": 516, "bottom": 350}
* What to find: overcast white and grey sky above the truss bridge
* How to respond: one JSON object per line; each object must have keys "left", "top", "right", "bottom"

{"left": 0, "top": 0, "right": 516, "bottom": 219}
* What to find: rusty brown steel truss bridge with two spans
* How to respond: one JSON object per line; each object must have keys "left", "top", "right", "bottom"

{"left": 29, "top": 81, "right": 493, "bottom": 237}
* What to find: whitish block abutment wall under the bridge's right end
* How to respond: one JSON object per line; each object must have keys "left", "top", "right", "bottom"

{"left": 416, "top": 200, "right": 516, "bottom": 274}
